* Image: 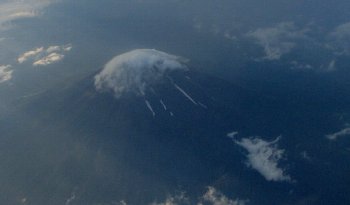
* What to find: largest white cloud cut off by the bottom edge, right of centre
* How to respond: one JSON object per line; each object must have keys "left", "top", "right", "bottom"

{"left": 198, "top": 187, "right": 248, "bottom": 205}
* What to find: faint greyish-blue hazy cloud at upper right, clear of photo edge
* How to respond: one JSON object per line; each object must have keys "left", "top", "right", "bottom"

{"left": 247, "top": 22, "right": 308, "bottom": 60}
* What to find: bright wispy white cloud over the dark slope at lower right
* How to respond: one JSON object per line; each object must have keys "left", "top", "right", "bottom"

{"left": 235, "top": 137, "right": 291, "bottom": 181}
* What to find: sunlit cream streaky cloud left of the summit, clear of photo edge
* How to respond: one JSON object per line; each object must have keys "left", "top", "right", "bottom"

{"left": 17, "top": 44, "right": 72, "bottom": 66}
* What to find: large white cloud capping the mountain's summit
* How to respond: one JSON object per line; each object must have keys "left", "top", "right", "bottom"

{"left": 95, "top": 49, "right": 187, "bottom": 97}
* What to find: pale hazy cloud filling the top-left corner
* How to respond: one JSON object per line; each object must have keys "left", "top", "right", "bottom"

{"left": 0, "top": 0, "right": 51, "bottom": 30}
